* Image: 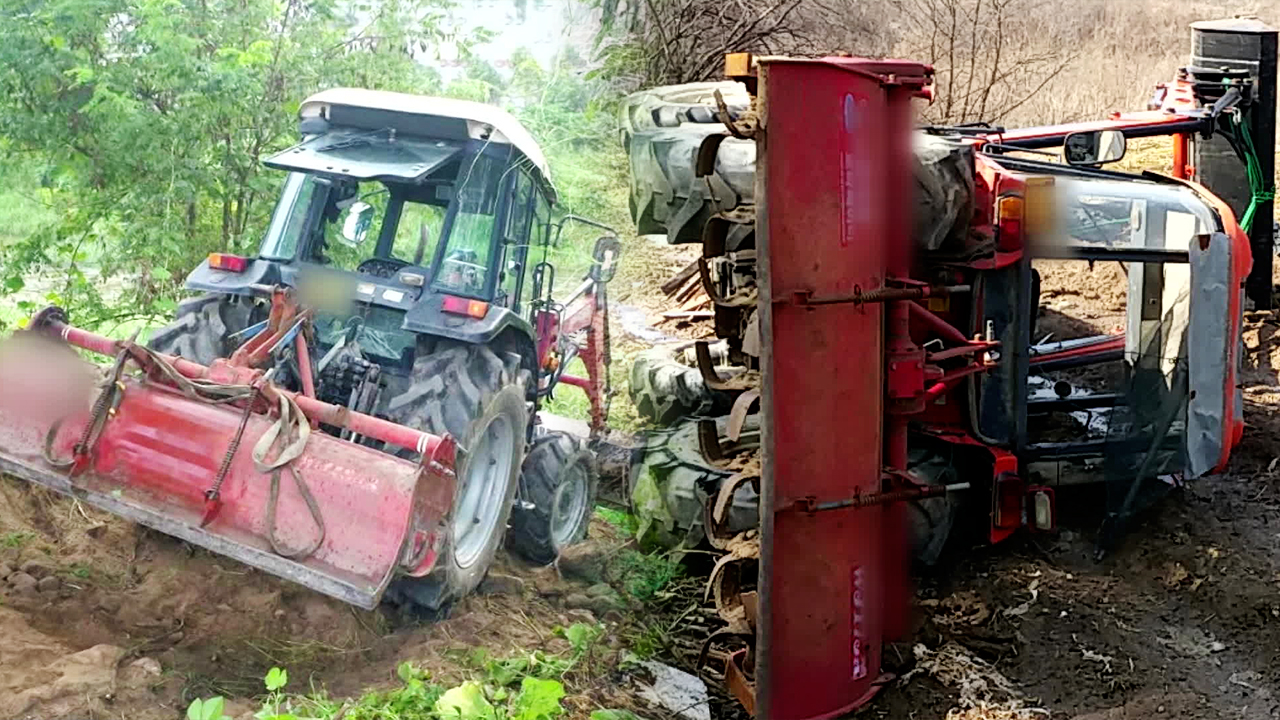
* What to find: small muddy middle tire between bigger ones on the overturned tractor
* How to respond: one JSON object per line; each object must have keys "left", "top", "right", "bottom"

{"left": 628, "top": 347, "right": 733, "bottom": 425}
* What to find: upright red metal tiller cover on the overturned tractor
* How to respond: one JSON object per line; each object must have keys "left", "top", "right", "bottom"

{"left": 756, "top": 58, "right": 932, "bottom": 719}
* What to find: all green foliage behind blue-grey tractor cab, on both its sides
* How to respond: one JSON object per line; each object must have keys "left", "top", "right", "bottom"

{"left": 0, "top": 0, "right": 626, "bottom": 332}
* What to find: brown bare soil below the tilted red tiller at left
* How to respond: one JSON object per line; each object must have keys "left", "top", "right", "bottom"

{"left": 0, "top": 478, "right": 655, "bottom": 720}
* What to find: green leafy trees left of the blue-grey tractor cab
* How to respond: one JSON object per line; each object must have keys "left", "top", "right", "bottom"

{"left": 0, "top": 0, "right": 472, "bottom": 323}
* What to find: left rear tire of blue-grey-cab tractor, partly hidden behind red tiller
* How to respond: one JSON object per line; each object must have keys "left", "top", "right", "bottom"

{"left": 147, "top": 293, "right": 253, "bottom": 365}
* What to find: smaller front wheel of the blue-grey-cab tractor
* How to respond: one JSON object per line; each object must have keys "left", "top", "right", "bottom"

{"left": 507, "top": 432, "right": 599, "bottom": 565}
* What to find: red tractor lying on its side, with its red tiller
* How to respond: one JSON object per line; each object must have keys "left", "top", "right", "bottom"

{"left": 623, "top": 41, "right": 1270, "bottom": 719}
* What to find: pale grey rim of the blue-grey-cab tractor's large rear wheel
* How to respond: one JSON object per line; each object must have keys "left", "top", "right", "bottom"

{"left": 453, "top": 415, "right": 516, "bottom": 568}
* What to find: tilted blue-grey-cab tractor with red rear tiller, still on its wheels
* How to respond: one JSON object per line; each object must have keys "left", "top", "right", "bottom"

{"left": 0, "top": 90, "right": 620, "bottom": 610}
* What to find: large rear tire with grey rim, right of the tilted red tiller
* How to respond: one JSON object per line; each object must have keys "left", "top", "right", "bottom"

{"left": 387, "top": 338, "right": 529, "bottom": 612}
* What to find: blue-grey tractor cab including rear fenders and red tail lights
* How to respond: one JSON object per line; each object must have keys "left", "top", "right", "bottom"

{"left": 179, "top": 88, "right": 576, "bottom": 401}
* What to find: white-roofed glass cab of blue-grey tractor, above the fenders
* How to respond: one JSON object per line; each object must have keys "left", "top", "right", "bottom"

{"left": 259, "top": 90, "right": 556, "bottom": 304}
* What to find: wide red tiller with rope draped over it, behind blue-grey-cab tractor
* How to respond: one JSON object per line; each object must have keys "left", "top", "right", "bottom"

{"left": 0, "top": 314, "right": 454, "bottom": 609}
